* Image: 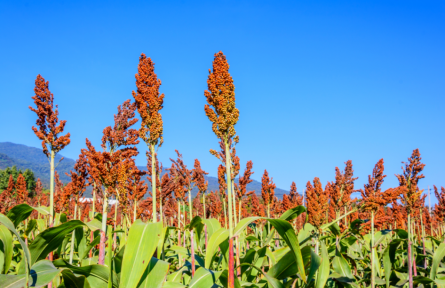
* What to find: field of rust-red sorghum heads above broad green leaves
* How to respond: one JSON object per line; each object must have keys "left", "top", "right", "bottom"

{"left": 0, "top": 52, "right": 445, "bottom": 288}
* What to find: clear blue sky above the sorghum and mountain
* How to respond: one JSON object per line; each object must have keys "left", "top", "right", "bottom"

{"left": 0, "top": 0, "right": 445, "bottom": 202}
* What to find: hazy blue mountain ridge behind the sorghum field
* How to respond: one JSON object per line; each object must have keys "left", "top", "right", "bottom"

{"left": 0, "top": 142, "right": 288, "bottom": 198}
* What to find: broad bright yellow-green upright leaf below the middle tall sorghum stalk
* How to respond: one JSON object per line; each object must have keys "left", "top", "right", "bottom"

{"left": 120, "top": 219, "right": 162, "bottom": 288}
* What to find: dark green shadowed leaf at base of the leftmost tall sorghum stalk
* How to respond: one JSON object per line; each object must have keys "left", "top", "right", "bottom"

{"left": 29, "top": 220, "right": 85, "bottom": 264}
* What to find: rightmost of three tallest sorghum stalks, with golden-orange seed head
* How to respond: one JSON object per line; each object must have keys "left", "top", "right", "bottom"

{"left": 204, "top": 52, "right": 239, "bottom": 288}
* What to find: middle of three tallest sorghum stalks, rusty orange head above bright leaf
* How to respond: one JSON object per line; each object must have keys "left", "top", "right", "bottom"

{"left": 133, "top": 54, "right": 164, "bottom": 222}
